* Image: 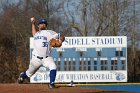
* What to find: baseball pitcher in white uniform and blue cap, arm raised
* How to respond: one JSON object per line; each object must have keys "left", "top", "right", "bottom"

{"left": 18, "top": 17, "right": 65, "bottom": 89}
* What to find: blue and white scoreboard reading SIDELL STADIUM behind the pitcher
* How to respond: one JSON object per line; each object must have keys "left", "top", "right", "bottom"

{"left": 30, "top": 36, "right": 127, "bottom": 83}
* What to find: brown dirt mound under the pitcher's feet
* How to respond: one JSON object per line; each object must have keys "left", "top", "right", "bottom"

{"left": 0, "top": 84, "right": 130, "bottom": 93}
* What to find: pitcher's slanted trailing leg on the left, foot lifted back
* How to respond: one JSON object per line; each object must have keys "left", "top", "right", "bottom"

{"left": 18, "top": 58, "right": 42, "bottom": 83}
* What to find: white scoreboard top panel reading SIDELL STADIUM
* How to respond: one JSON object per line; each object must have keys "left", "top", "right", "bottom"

{"left": 30, "top": 36, "right": 127, "bottom": 48}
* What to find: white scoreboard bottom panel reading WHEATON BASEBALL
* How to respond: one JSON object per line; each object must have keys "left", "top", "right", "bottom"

{"left": 30, "top": 71, "right": 127, "bottom": 83}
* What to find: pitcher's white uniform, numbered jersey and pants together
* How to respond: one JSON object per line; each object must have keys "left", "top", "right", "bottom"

{"left": 26, "top": 30, "right": 59, "bottom": 77}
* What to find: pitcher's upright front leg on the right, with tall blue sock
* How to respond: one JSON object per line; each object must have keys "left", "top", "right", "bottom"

{"left": 43, "top": 57, "right": 57, "bottom": 88}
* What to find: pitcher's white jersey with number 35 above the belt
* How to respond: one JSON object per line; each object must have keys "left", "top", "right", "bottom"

{"left": 32, "top": 30, "right": 58, "bottom": 57}
